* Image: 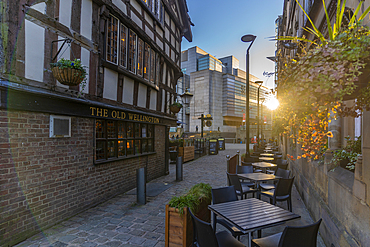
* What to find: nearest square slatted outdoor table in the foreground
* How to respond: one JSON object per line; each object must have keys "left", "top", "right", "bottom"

{"left": 208, "top": 198, "right": 301, "bottom": 246}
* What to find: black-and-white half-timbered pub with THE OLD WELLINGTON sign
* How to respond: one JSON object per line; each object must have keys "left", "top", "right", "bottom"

{"left": 0, "top": 0, "right": 192, "bottom": 246}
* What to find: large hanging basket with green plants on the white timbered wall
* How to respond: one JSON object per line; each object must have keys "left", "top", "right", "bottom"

{"left": 50, "top": 58, "right": 86, "bottom": 87}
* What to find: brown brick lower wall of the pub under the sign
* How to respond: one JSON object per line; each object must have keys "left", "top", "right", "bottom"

{"left": 0, "top": 110, "right": 165, "bottom": 246}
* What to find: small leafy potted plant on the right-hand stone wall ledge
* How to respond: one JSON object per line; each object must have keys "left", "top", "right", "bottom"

{"left": 332, "top": 137, "right": 361, "bottom": 171}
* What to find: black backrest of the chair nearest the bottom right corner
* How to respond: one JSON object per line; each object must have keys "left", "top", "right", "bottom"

{"left": 279, "top": 219, "right": 321, "bottom": 247}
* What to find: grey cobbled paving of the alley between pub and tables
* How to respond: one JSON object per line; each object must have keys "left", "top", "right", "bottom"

{"left": 16, "top": 144, "right": 325, "bottom": 247}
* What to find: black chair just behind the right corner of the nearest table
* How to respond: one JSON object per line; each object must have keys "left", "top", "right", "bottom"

{"left": 261, "top": 177, "right": 294, "bottom": 212}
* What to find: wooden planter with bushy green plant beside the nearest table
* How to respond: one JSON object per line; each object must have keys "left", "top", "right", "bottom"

{"left": 165, "top": 183, "right": 212, "bottom": 247}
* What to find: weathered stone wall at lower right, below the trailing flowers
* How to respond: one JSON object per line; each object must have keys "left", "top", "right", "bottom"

{"left": 280, "top": 122, "right": 370, "bottom": 247}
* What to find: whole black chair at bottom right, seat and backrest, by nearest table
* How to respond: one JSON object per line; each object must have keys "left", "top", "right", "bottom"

{"left": 252, "top": 219, "right": 321, "bottom": 247}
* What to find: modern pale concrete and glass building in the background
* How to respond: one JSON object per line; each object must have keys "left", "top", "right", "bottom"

{"left": 178, "top": 46, "right": 271, "bottom": 139}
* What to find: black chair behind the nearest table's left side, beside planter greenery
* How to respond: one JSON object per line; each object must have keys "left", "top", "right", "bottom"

{"left": 212, "top": 185, "right": 243, "bottom": 239}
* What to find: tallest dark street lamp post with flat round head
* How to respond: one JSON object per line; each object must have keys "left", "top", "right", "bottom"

{"left": 241, "top": 34, "right": 257, "bottom": 158}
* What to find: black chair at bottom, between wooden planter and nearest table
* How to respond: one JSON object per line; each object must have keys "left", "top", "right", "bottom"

{"left": 189, "top": 209, "right": 245, "bottom": 247}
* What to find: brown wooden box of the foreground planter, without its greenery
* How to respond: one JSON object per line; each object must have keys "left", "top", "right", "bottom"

{"left": 165, "top": 202, "right": 211, "bottom": 247}
